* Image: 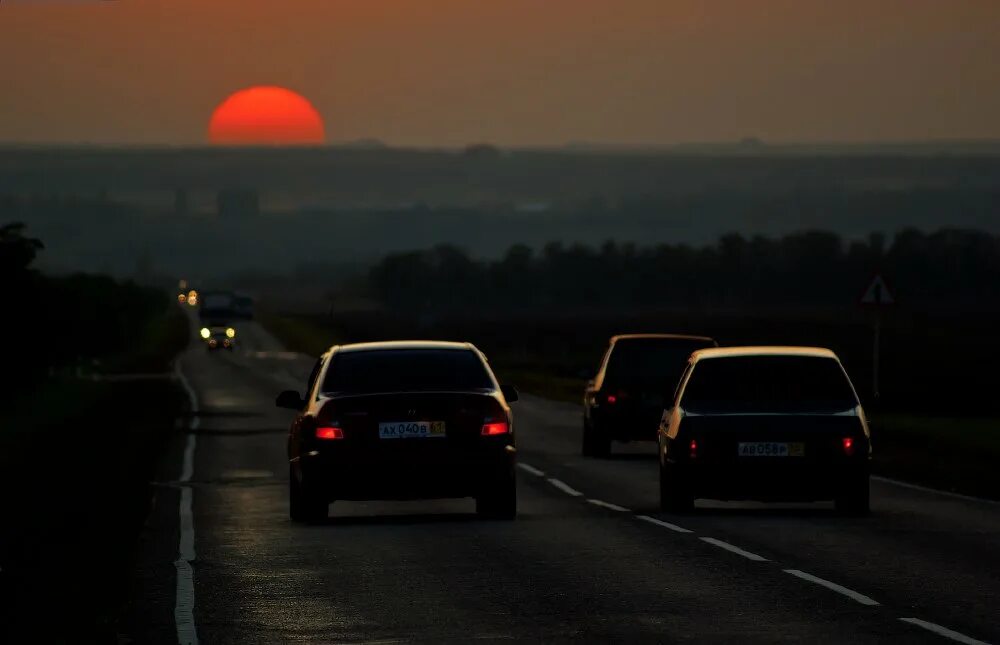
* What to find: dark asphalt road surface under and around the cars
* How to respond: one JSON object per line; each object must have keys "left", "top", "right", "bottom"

{"left": 128, "top": 325, "right": 1000, "bottom": 643}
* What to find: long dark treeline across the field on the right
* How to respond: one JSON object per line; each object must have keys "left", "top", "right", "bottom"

{"left": 369, "top": 229, "right": 1000, "bottom": 312}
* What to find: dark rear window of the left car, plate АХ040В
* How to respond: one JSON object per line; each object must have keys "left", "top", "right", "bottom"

{"left": 323, "top": 349, "right": 494, "bottom": 393}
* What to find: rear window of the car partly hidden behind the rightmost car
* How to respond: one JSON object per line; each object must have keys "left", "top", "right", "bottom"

{"left": 604, "top": 338, "right": 715, "bottom": 394}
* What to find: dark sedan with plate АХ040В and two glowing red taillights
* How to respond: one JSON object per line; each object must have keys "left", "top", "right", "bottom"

{"left": 276, "top": 341, "right": 517, "bottom": 521}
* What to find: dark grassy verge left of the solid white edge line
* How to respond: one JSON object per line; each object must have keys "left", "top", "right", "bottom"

{"left": 0, "top": 307, "right": 187, "bottom": 643}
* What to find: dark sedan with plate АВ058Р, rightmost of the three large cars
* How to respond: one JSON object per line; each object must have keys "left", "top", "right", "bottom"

{"left": 658, "top": 347, "right": 871, "bottom": 514}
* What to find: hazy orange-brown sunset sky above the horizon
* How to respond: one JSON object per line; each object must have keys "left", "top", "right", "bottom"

{"left": 0, "top": 0, "right": 1000, "bottom": 146}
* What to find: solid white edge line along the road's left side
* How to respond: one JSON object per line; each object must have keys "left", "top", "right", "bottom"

{"left": 174, "top": 361, "right": 199, "bottom": 645}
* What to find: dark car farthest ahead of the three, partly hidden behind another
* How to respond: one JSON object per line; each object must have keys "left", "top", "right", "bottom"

{"left": 583, "top": 334, "right": 718, "bottom": 457}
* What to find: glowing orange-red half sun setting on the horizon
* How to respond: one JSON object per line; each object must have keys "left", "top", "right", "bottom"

{"left": 208, "top": 85, "right": 326, "bottom": 145}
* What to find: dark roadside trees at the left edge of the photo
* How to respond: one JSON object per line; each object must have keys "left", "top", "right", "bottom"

{"left": 0, "top": 223, "right": 169, "bottom": 398}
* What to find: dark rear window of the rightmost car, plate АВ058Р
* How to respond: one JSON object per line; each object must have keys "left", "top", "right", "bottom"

{"left": 681, "top": 356, "right": 858, "bottom": 414}
